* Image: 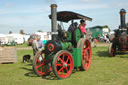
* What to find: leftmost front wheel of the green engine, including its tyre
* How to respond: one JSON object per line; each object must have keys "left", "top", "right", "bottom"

{"left": 33, "top": 51, "right": 51, "bottom": 76}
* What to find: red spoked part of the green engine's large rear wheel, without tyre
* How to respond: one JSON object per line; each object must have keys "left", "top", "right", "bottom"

{"left": 82, "top": 40, "right": 91, "bottom": 70}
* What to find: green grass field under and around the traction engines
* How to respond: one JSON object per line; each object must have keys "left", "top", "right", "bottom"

{"left": 0, "top": 47, "right": 128, "bottom": 85}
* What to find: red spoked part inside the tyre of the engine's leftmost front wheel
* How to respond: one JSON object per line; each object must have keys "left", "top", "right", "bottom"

{"left": 34, "top": 52, "right": 51, "bottom": 75}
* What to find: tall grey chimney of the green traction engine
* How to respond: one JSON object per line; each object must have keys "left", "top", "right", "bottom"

{"left": 51, "top": 4, "right": 57, "bottom": 40}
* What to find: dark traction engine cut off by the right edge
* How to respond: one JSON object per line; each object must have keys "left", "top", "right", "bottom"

{"left": 109, "top": 9, "right": 128, "bottom": 56}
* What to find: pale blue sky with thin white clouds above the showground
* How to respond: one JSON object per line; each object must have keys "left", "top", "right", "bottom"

{"left": 0, "top": 0, "right": 128, "bottom": 34}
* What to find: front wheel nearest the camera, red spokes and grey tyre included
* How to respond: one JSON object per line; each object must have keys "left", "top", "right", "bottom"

{"left": 52, "top": 50, "right": 74, "bottom": 79}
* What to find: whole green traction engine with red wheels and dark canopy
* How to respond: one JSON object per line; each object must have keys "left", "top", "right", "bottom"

{"left": 33, "top": 4, "right": 92, "bottom": 79}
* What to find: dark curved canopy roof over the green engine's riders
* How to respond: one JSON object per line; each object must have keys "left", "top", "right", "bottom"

{"left": 49, "top": 11, "right": 92, "bottom": 22}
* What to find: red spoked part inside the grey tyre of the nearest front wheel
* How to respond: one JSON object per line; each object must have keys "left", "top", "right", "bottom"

{"left": 56, "top": 52, "right": 73, "bottom": 78}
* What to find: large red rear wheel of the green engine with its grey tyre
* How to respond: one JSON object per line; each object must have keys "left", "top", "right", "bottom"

{"left": 77, "top": 38, "right": 91, "bottom": 70}
